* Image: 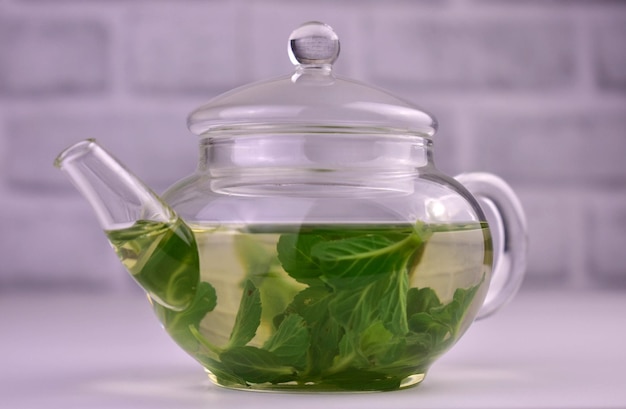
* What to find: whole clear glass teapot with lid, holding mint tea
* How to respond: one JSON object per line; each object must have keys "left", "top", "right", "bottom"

{"left": 56, "top": 22, "right": 526, "bottom": 391}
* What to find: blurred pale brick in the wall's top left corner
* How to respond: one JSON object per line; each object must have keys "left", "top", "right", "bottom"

{"left": 0, "top": 13, "right": 110, "bottom": 97}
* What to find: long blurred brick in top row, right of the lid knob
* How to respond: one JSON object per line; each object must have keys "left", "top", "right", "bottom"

{"left": 366, "top": 15, "right": 576, "bottom": 92}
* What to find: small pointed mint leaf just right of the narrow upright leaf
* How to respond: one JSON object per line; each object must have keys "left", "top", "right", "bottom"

{"left": 263, "top": 314, "right": 310, "bottom": 368}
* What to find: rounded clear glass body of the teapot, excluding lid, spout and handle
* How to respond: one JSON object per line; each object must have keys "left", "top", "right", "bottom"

{"left": 149, "top": 134, "right": 493, "bottom": 391}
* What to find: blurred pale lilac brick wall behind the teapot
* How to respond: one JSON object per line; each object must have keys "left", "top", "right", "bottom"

{"left": 0, "top": 0, "right": 626, "bottom": 292}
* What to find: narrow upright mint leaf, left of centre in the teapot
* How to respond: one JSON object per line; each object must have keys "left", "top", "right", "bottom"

{"left": 226, "top": 280, "right": 261, "bottom": 348}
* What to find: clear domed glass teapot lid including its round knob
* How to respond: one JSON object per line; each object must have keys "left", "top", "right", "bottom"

{"left": 187, "top": 22, "right": 437, "bottom": 137}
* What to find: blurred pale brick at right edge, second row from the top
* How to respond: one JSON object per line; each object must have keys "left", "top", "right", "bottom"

{"left": 469, "top": 110, "right": 626, "bottom": 183}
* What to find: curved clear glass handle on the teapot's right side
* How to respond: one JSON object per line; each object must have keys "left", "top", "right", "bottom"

{"left": 455, "top": 172, "right": 527, "bottom": 319}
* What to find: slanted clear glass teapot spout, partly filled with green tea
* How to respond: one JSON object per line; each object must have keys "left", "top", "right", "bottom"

{"left": 54, "top": 139, "right": 200, "bottom": 311}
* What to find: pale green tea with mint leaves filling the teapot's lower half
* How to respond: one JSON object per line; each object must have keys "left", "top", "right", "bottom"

{"left": 109, "top": 218, "right": 492, "bottom": 391}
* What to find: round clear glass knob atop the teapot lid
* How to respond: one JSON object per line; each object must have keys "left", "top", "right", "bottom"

{"left": 289, "top": 21, "right": 339, "bottom": 67}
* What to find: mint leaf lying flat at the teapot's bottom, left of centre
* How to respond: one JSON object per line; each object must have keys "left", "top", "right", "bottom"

{"left": 220, "top": 346, "right": 296, "bottom": 383}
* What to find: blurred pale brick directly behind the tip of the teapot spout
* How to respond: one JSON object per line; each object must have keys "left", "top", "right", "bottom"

{"left": 5, "top": 112, "right": 197, "bottom": 190}
